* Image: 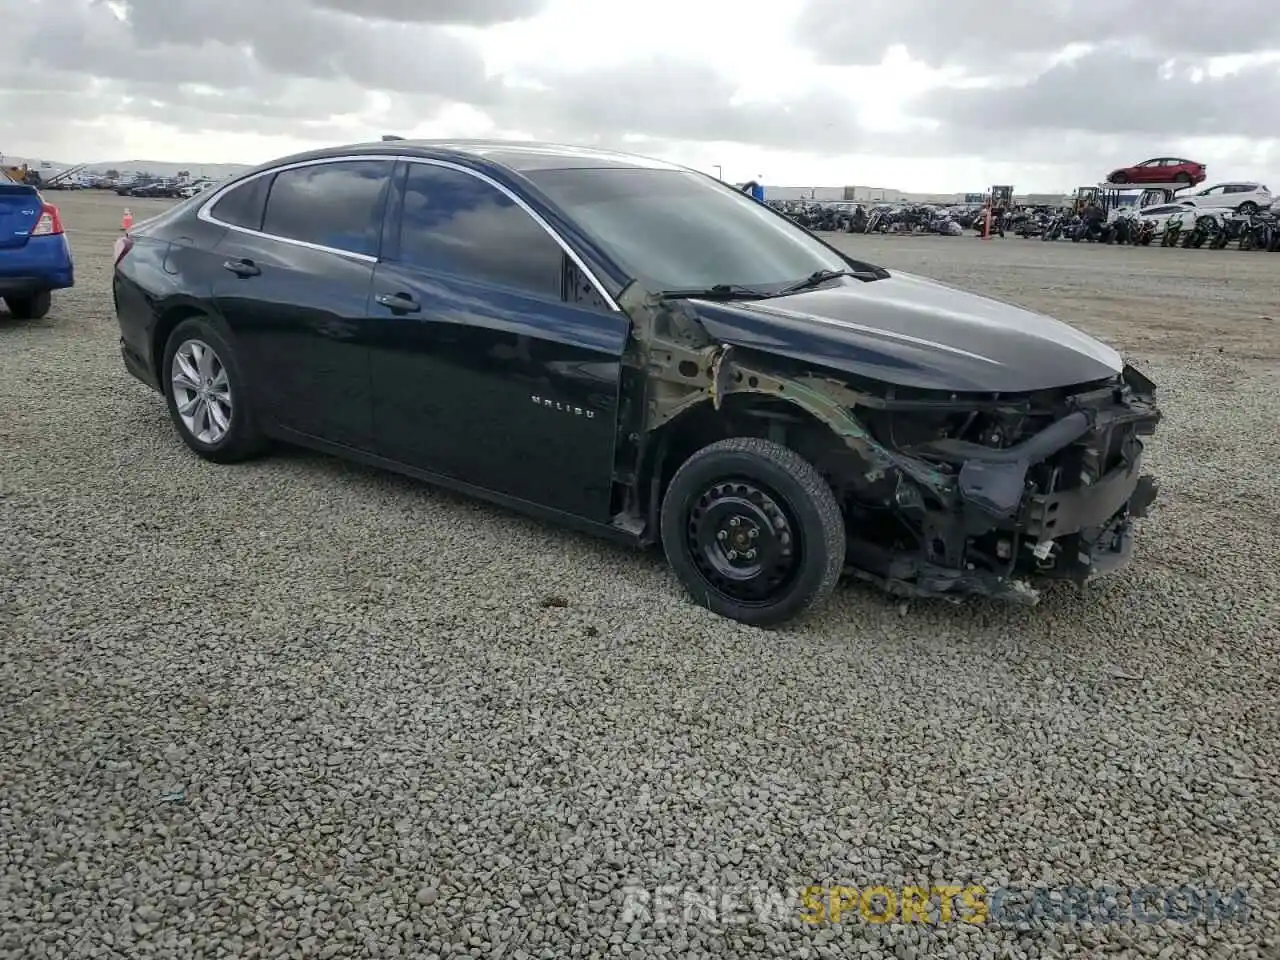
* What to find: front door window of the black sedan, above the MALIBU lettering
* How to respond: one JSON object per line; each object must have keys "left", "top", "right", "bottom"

{"left": 396, "top": 164, "right": 564, "bottom": 298}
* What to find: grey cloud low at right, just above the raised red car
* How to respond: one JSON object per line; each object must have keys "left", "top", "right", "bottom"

{"left": 909, "top": 46, "right": 1280, "bottom": 138}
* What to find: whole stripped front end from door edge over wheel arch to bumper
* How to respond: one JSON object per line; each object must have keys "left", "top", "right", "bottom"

{"left": 614, "top": 284, "right": 1161, "bottom": 603}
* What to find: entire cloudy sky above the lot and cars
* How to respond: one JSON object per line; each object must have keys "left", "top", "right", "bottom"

{"left": 0, "top": 0, "right": 1280, "bottom": 191}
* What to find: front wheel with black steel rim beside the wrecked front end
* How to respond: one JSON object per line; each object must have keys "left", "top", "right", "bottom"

{"left": 662, "top": 436, "right": 845, "bottom": 626}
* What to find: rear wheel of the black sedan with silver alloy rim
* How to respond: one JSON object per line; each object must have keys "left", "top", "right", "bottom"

{"left": 161, "top": 317, "right": 262, "bottom": 463}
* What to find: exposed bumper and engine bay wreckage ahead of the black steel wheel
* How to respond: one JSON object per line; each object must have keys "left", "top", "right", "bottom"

{"left": 844, "top": 366, "right": 1161, "bottom": 603}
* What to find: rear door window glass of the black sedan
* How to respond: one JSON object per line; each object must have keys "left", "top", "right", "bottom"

{"left": 262, "top": 160, "right": 392, "bottom": 256}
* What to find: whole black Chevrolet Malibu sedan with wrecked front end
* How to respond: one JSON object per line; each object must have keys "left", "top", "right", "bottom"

{"left": 114, "top": 141, "right": 1160, "bottom": 626}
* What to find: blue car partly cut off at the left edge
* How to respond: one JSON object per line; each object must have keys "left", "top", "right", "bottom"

{"left": 0, "top": 178, "right": 76, "bottom": 320}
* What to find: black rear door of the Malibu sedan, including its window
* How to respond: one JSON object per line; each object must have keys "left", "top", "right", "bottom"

{"left": 210, "top": 157, "right": 393, "bottom": 449}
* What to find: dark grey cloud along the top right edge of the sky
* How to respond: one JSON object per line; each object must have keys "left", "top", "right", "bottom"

{"left": 796, "top": 0, "right": 1280, "bottom": 73}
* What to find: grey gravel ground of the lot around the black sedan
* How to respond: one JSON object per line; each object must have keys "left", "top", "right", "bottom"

{"left": 0, "top": 195, "right": 1280, "bottom": 960}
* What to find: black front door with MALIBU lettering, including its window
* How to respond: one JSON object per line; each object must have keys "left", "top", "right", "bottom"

{"left": 370, "top": 161, "right": 630, "bottom": 521}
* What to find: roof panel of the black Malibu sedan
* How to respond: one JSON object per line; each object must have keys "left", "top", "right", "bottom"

{"left": 240, "top": 140, "right": 685, "bottom": 173}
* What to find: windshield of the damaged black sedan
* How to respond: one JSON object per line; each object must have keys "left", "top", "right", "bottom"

{"left": 527, "top": 168, "right": 870, "bottom": 291}
